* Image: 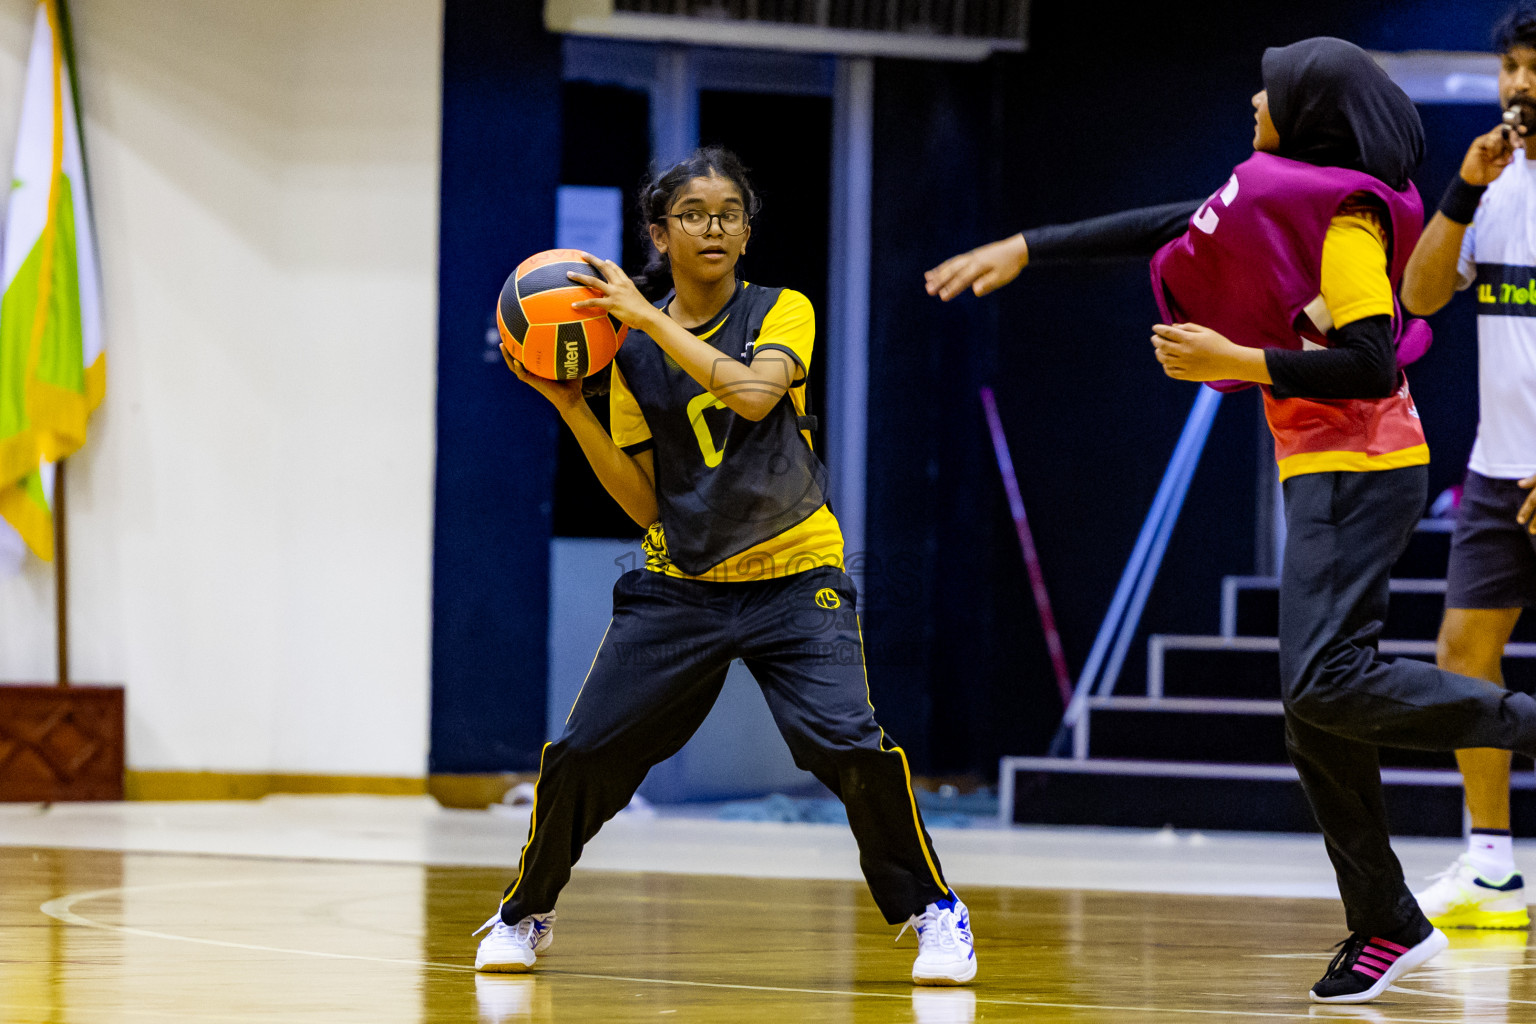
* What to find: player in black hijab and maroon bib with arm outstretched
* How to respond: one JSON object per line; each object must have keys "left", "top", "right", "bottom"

{"left": 928, "top": 38, "right": 1536, "bottom": 1003}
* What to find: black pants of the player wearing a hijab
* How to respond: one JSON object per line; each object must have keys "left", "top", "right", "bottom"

{"left": 1279, "top": 467, "right": 1536, "bottom": 935}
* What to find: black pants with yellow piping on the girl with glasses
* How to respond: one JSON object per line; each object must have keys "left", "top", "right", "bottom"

{"left": 501, "top": 568, "right": 949, "bottom": 924}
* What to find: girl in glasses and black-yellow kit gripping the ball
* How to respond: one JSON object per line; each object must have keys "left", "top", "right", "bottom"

{"left": 475, "top": 149, "right": 975, "bottom": 984}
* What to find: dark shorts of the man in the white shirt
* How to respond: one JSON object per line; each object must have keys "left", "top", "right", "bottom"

{"left": 1445, "top": 470, "right": 1536, "bottom": 608}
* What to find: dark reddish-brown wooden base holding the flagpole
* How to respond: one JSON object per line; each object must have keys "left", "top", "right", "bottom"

{"left": 0, "top": 683, "right": 123, "bottom": 803}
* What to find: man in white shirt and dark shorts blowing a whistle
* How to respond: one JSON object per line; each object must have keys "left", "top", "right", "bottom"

{"left": 1402, "top": 2, "right": 1536, "bottom": 929}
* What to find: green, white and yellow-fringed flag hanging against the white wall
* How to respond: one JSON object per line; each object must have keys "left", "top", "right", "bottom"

{"left": 0, "top": 0, "right": 106, "bottom": 568}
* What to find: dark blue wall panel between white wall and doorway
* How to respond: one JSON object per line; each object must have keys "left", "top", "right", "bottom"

{"left": 430, "top": 0, "right": 561, "bottom": 772}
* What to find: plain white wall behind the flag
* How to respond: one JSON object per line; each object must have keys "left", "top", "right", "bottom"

{"left": 0, "top": 0, "right": 442, "bottom": 775}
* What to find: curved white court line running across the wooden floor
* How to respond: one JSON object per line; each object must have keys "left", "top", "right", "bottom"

{"left": 38, "top": 880, "right": 1475, "bottom": 1024}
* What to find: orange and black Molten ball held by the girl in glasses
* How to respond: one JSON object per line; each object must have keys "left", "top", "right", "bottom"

{"left": 496, "top": 249, "right": 630, "bottom": 381}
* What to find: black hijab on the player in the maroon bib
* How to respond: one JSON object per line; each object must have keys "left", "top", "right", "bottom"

{"left": 1264, "top": 35, "right": 1424, "bottom": 192}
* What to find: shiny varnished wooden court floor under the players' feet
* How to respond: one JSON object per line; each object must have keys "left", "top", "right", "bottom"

{"left": 0, "top": 847, "right": 1536, "bottom": 1024}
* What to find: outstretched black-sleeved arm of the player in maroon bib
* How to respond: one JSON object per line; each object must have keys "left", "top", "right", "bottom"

{"left": 923, "top": 200, "right": 1204, "bottom": 302}
